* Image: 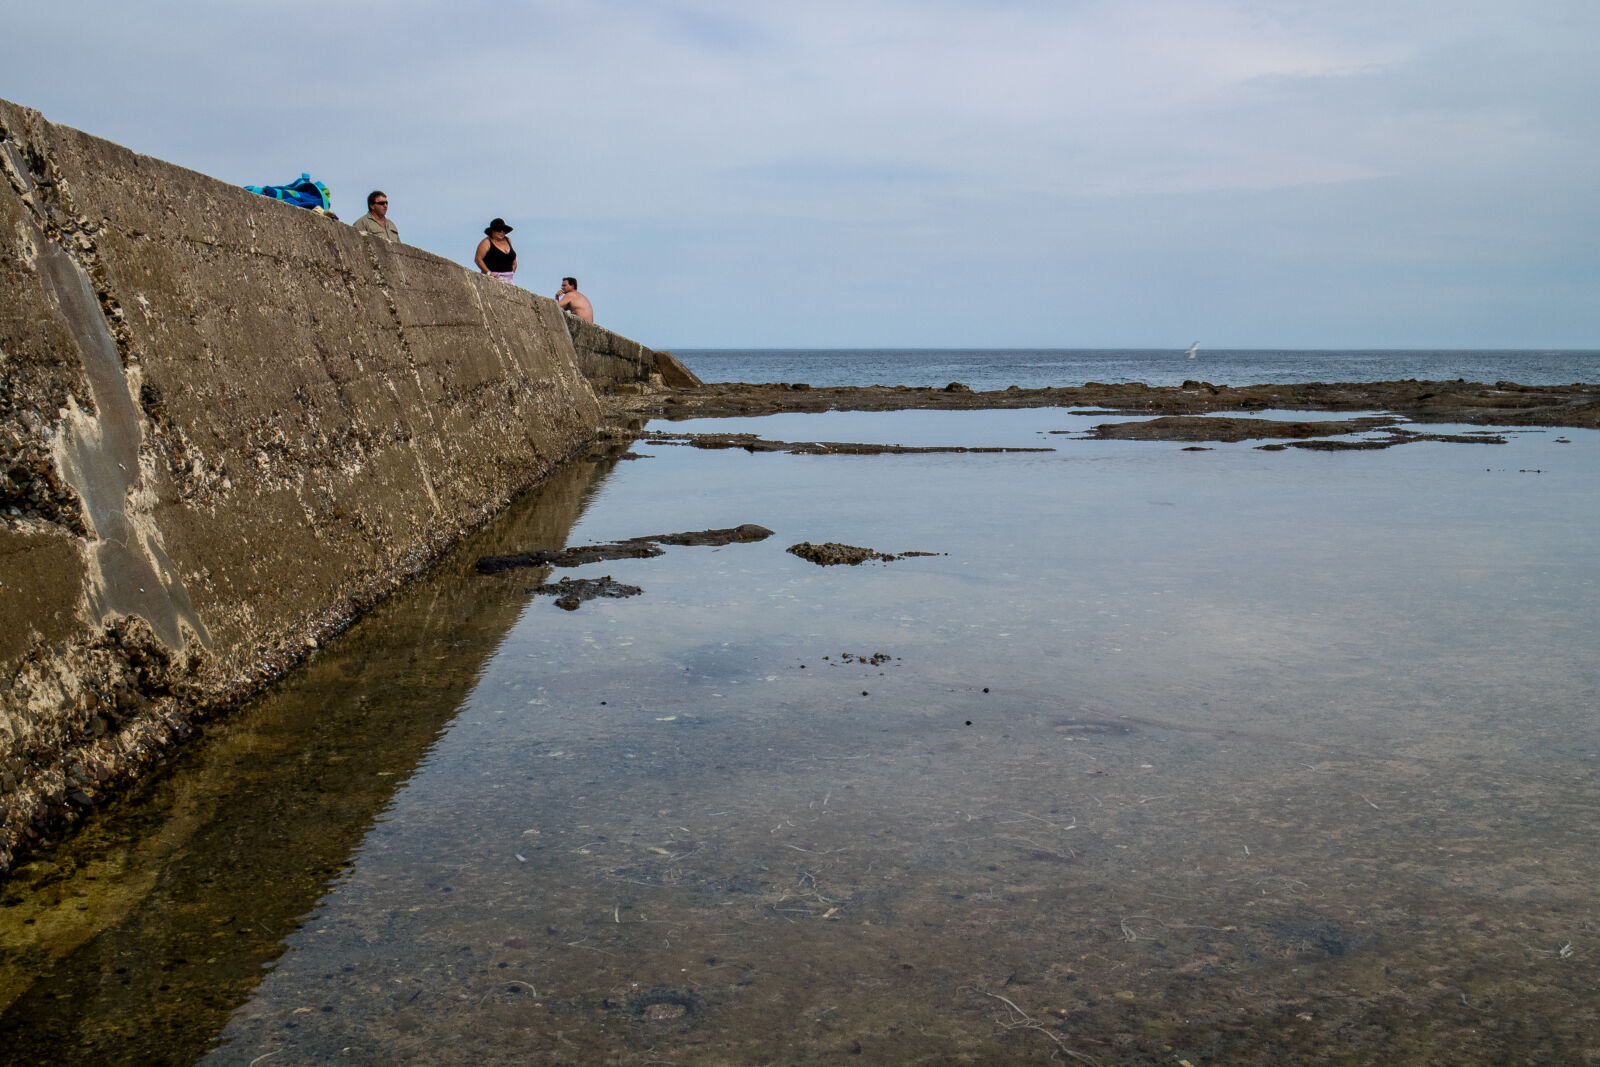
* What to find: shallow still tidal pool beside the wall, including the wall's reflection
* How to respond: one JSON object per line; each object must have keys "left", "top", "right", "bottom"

{"left": 0, "top": 410, "right": 1600, "bottom": 1064}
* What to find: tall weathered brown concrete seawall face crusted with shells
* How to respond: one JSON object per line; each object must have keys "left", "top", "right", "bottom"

{"left": 0, "top": 101, "right": 598, "bottom": 870}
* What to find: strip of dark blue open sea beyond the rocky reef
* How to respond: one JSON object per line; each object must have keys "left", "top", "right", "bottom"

{"left": 674, "top": 347, "right": 1600, "bottom": 390}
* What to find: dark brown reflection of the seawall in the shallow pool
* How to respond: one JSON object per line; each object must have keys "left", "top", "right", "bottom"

{"left": 0, "top": 459, "right": 614, "bottom": 1062}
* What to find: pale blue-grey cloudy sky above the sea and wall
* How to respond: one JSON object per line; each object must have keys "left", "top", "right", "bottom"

{"left": 0, "top": 0, "right": 1600, "bottom": 349}
